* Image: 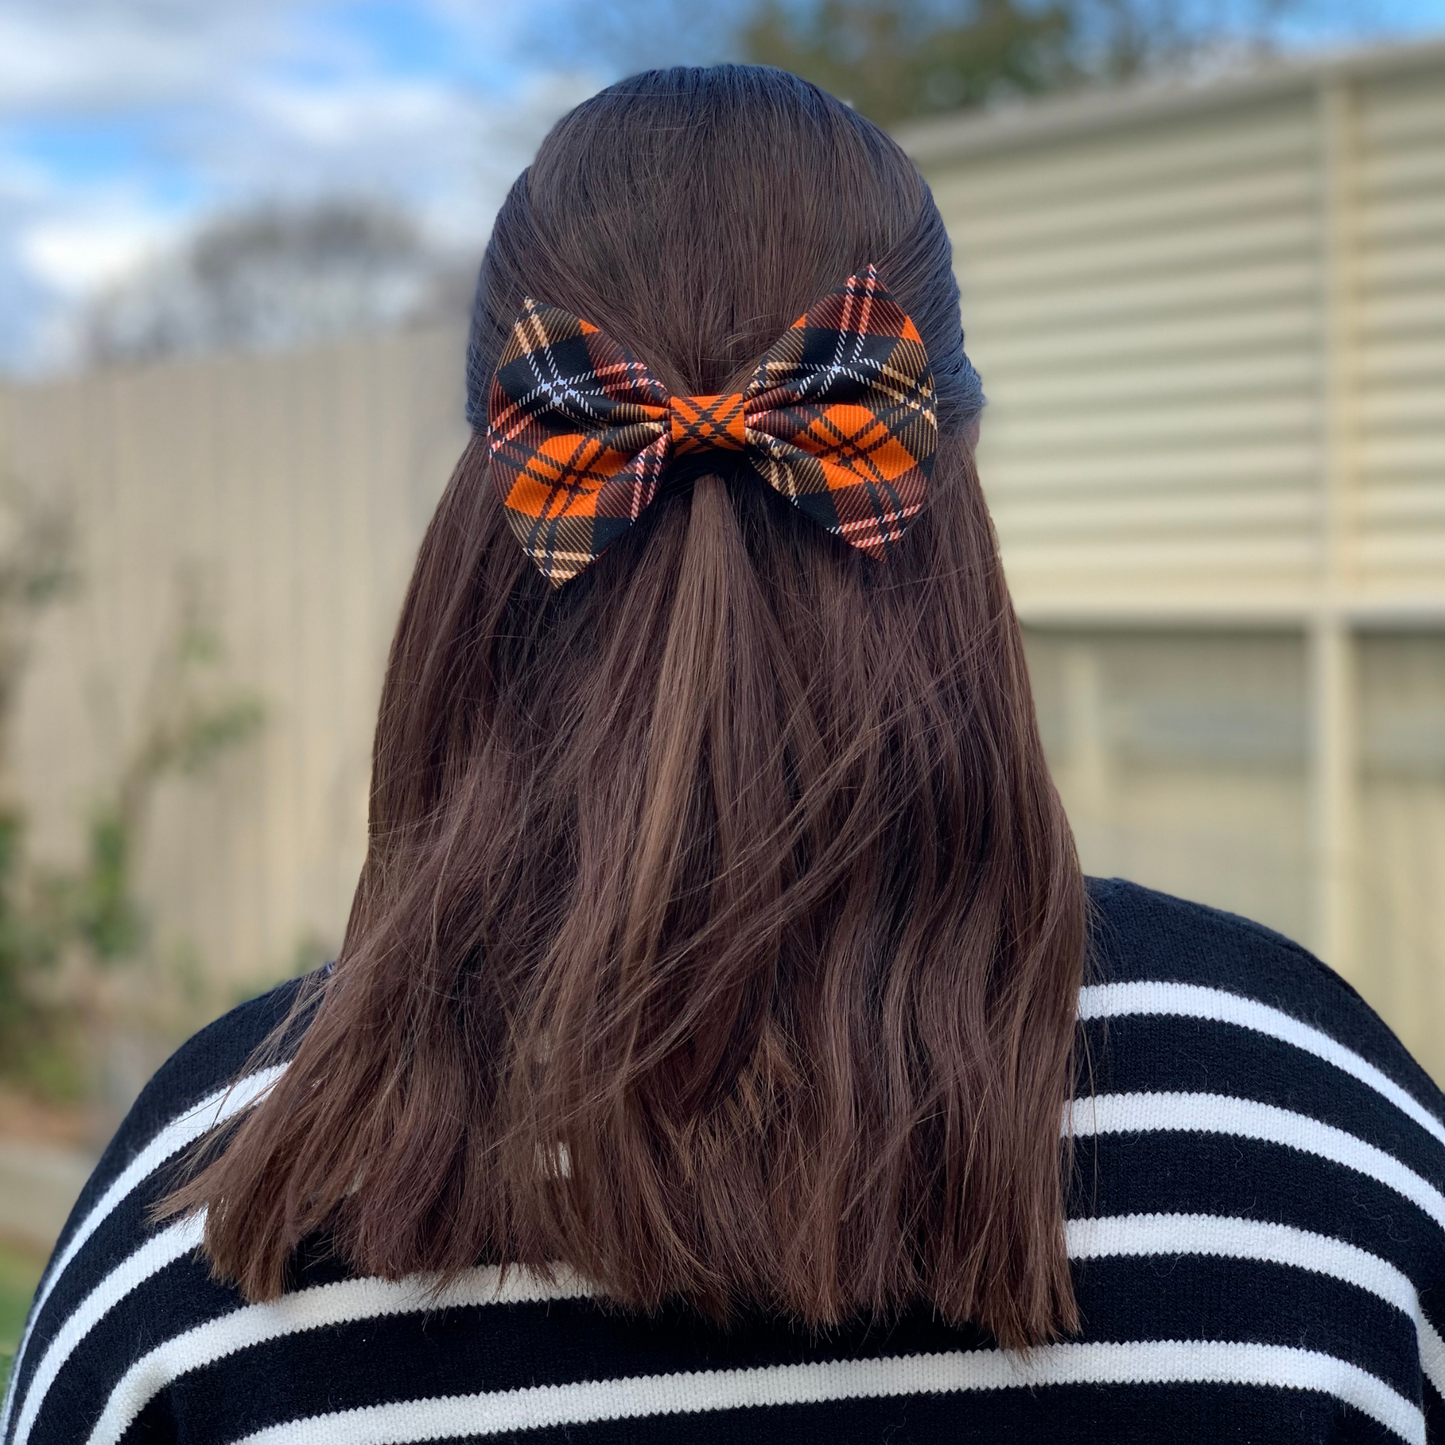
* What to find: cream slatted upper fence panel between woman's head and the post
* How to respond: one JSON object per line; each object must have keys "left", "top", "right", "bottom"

{"left": 933, "top": 97, "right": 1321, "bottom": 611}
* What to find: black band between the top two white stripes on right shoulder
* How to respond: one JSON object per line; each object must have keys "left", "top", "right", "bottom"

{"left": 1084, "top": 1014, "right": 1445, "bottom": 1189}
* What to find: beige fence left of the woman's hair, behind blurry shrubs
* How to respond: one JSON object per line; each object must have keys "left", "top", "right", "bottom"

{"left": 0, "top": 328, "right": 467, "bottom": 991}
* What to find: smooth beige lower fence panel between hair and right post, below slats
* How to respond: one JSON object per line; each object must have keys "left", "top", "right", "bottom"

{"left": 1026, "top": 629, "right": 1311, "bottom": 938}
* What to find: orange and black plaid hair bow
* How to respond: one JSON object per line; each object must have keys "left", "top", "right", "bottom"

{"left": 487, "top": 266, "right": 938, "bottom": 587}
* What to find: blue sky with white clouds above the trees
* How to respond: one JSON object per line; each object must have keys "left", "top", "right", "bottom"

{"left": 0, "top": 0, "right": 1445, "bottom": 373}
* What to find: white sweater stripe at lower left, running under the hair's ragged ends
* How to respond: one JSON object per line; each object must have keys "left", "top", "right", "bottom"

{"left": 90, "top": 1266, "right": 591, "bottom": 1445}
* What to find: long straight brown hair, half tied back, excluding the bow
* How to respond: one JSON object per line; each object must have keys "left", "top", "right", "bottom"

{"left": 169, "top": 66, "right": 1085, "bottom": 1344}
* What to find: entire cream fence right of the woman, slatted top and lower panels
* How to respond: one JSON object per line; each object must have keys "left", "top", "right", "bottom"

{"left": 906, "top": 45, "right": 1445, "bottom": 1078}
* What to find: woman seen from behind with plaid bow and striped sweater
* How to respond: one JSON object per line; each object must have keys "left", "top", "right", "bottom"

{"left": 4, "top": 68, "right": 1445, "bottom": 1445}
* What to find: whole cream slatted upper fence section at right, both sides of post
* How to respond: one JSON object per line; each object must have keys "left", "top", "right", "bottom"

{"left": 922, "top": 55, "right": 1445, "bottom": 618}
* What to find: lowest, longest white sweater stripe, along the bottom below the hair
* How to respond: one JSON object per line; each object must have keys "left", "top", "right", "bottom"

{"left": 222, "top": 1340, "right": 1425, "bottom": 1445}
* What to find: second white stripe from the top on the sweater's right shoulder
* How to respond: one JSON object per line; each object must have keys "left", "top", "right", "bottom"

{"left": 1064, "top": 1092, "right": 1445, "bottom": 1228}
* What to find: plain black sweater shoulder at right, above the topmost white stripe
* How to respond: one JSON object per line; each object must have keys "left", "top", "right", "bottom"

{"left": 1087, "top": 879, "right": 1445, "bottom": 1118}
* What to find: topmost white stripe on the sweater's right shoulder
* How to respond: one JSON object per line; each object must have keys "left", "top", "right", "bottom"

{"left": 1078, "top": 980, "right": 1445, "bottom": 1144}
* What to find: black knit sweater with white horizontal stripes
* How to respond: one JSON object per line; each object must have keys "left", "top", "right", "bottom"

{"left": 0, "top": 881, "right": 1445, "bottom": 1445}
